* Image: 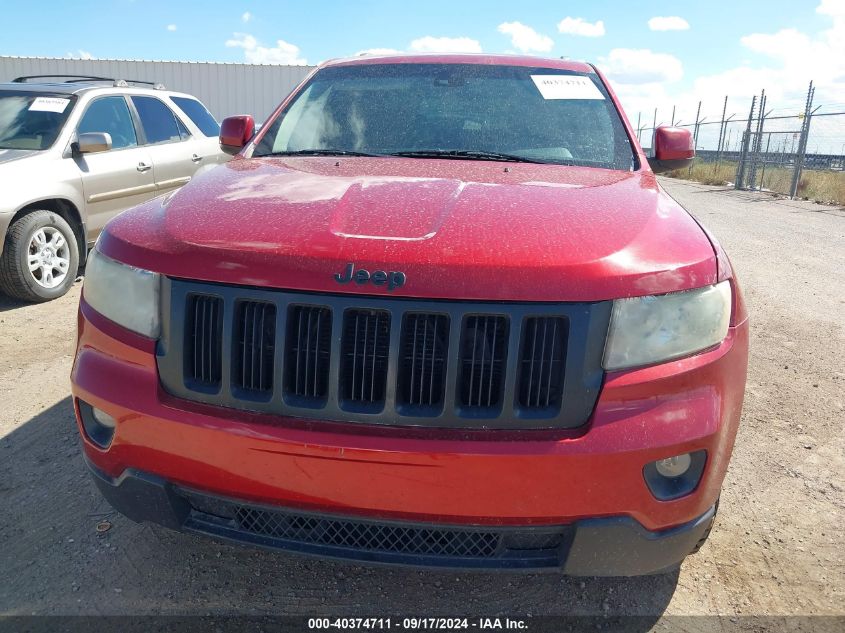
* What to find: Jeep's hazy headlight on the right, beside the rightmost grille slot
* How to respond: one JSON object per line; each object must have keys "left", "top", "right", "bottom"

{"left": 602, "top": 281, "right": 731, "bottom": 369}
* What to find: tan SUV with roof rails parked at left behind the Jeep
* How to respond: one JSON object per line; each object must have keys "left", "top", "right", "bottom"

{"left": 0, "top": 75, "right": 229, "bottom": 301}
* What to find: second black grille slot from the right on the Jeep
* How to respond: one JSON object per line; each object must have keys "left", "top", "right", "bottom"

{"left": 459, "top": 316, "right": 508, "bottom": 414}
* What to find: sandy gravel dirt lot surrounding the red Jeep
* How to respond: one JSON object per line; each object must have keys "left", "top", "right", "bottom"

{"left": 0, "top": 181, "right": 845, "bottom": 616}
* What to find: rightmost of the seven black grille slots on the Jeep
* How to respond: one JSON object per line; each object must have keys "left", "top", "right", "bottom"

{"left": 517, "top": 317, "right": 567, "bottom": 410}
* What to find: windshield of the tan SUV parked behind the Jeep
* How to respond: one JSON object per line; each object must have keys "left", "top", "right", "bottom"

{"left": 0, "top": 90, "right": 76, "bottom": 150}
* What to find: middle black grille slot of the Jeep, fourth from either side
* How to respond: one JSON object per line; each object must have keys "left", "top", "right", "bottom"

{"left": 340, "top": 310, "right": 390, "bottom": 406}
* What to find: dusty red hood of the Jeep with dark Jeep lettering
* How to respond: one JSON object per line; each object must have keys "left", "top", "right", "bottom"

{"left": 100, "top": 157, "right": 716, "bottom": 301}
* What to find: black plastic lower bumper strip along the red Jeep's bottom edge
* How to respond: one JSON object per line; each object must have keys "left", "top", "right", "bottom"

{"left": 88, "top": 462, "right": 715, "bottom": 576}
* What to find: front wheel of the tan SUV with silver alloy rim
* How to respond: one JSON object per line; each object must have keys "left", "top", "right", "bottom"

{"left": 0, "top": 210, "right": 79, "bottom": 303}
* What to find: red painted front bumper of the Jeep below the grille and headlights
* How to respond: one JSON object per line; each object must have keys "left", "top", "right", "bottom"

{"left": 72, "top": 302, "right": 748, "bottom": 574}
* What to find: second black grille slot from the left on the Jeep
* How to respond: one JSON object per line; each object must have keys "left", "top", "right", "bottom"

{"left": 232, "top": 301, "right": 276, "bottom": 393}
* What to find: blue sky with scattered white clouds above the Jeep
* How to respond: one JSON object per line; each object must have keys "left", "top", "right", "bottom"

{"left": 0, "top": 0, "right": 845, "bottom": 123}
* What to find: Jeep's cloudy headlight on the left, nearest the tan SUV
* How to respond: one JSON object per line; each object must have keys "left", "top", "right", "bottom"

{"left": 82, "top": 248, "right": 161, "bottom": 338}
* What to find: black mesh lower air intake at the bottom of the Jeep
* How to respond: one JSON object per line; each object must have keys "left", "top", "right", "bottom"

{"left": 179, "top": 487, "right": 575, "bottom": 569}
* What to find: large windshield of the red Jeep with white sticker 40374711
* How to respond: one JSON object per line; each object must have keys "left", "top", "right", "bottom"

{"left": 253, "top": 64, "right": 634, "bottom": 170}
